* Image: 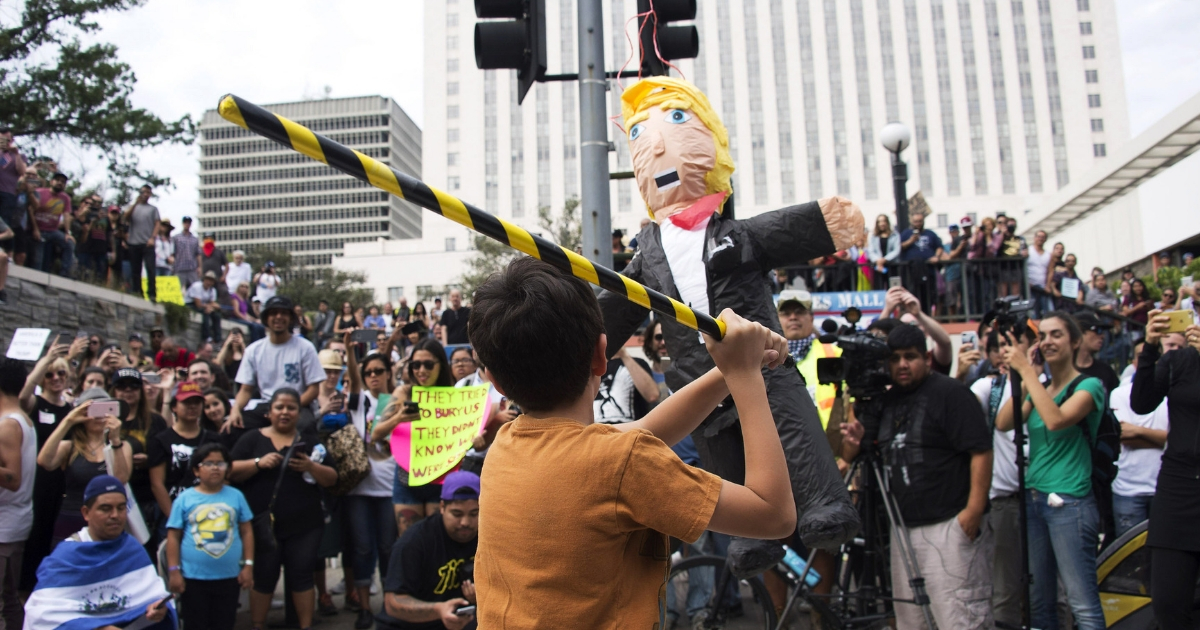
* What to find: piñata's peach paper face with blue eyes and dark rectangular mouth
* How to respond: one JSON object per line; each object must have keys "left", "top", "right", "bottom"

{"left": 629, "top": 108, "right": 716, "bottom": 211}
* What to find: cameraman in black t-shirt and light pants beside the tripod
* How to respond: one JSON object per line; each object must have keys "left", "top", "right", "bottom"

{"left": 844, "top": 324, "right": 992, "bottom": 628}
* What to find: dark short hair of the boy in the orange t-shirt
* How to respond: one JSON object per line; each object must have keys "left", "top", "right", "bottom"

{"left": 467, "top": 257, "right": 604, "bottom": 412}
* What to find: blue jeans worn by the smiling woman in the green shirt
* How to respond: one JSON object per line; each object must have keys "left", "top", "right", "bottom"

{"left": 1026, "top": 490, "right": 1105, "bottom": 630}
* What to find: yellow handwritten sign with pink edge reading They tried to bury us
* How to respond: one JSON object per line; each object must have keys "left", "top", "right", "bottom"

{"left": 391, "top": 385, "right": 491, "bottom": 486}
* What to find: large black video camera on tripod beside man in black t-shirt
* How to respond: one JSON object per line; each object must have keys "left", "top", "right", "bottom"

{"left": 817, "top": 306, "right": 892, "bottom": 398}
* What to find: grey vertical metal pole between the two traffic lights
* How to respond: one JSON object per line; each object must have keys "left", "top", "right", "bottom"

{"left": 578, "top": 0, "right": 612, "bottom": 269}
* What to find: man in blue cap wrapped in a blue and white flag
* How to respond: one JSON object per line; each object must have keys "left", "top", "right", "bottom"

{"left": 25, "top": 475, "right": 176, "bottom": 630}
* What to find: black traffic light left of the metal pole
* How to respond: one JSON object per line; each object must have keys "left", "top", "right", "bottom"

{"left": 475, "top": 0, "right": 549, "bottom": 103}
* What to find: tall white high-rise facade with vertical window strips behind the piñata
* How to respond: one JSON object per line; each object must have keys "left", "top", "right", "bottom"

{"left": 424, "top": 0, "right": 1129, "bottom": 242}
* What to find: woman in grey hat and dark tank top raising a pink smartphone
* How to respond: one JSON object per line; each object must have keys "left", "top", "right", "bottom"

{"left": 37, "top": 396, "right": 133, "bottom": 545}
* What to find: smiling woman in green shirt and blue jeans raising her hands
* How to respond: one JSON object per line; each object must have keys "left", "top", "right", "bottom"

{"left": 996, "top": 311, "right": 1105, "bottom": 630}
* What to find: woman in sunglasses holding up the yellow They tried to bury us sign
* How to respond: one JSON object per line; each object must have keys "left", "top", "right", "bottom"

{"left": 371, "top": 338, "right": 454, "bottom": 535}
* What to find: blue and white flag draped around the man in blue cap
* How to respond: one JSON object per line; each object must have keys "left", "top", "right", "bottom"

{"left": 24, "top": 533, "right": 178, "bottom": 630}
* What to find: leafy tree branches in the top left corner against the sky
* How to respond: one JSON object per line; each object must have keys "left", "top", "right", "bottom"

{"left": 0, "top": 0, "right": 196, "bottom": 203}
